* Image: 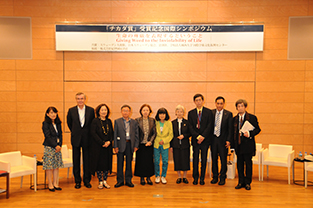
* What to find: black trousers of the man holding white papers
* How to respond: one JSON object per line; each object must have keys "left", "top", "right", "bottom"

{"left": 237, "top": 153, "right": 252, "bottom": 184}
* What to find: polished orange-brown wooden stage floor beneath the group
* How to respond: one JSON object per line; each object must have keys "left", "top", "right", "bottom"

{"left": 0, "top": 163, "right": 313, "bottom": 208}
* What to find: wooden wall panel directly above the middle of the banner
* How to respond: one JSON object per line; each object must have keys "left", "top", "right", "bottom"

{"left": 112, "top": 1, "right": 207, "bottom": 23}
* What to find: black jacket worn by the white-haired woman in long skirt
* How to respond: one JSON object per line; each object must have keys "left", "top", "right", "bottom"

{"left": 171, "top": 118, "right": 191, "bottom": 149}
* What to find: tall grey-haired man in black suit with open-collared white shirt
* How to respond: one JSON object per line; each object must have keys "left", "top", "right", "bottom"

{"left": 67, "top": 92, "right": 95, "bottom": 189}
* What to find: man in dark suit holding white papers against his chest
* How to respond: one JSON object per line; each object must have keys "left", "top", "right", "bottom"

{"left": 232, "top": 99, "right": 261, "bottom": 190}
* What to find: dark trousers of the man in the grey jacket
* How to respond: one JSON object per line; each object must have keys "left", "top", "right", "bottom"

{"left": 116, "top": 142, "right": 133, "bottom": 183}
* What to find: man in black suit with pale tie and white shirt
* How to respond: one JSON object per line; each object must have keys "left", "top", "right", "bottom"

{"left": 211, "top": 96, "right": 233, "bottom": 185}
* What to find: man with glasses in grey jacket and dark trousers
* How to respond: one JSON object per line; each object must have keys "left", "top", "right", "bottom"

{"left": 114, "top": 105, "right": 139, "bottom": 188}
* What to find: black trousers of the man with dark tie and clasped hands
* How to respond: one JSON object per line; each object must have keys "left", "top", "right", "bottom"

{"left": 192, "top": 144, "right": 209, "bottom": 180}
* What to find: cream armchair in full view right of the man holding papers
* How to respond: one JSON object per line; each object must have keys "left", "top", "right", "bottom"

{"left": 262, "top": 144, "right": 294, "bottom": 184}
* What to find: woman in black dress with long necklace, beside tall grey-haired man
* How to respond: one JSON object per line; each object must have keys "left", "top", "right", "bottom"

{"left": 90, "top": 104, "right": 114, "bottom": 189}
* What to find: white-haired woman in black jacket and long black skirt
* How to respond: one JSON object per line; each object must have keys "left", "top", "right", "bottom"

{"left": 171, "top": 105, "right": 191, "bottom": 184}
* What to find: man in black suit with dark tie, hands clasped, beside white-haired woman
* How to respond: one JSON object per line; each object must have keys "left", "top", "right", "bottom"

{"left": 188, "top": 94, "right": 213, "bottom": 185}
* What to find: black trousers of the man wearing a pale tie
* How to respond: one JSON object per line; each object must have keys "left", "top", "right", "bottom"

{"left": 211, "top": 136, "right": 228, "bottom": 179}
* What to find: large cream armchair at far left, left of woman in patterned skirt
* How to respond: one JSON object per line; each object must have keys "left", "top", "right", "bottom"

{"left": 0, "top": 151, "right": 37, "bottom": 192}
